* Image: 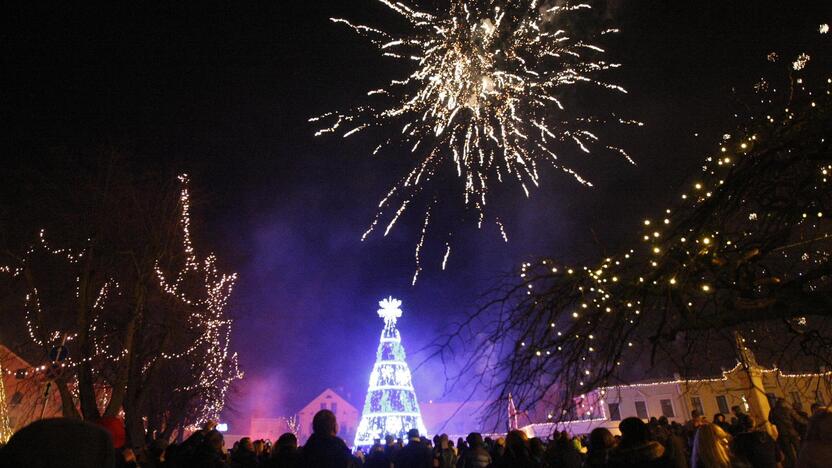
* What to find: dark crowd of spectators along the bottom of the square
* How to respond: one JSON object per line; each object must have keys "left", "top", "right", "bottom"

{"left": 0, "top": 399, "right": 832, "bottom": 468}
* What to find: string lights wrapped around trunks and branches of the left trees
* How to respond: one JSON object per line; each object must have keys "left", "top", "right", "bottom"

{"left": 0, "top": 174, "right": 243, "bottom": 427}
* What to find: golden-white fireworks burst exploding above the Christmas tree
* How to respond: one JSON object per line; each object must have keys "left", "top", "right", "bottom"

{"left": 310, "top": 0, "right": 640, "bottom": 280}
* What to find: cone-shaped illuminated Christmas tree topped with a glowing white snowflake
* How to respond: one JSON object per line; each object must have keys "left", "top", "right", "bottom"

{"left": 355, "top": 297, "right": 427, "bottom": 446}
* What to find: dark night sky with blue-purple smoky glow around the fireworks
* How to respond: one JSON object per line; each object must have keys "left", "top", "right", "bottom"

{"left": 0, "top": 0, "right": 832, "bottom": 432}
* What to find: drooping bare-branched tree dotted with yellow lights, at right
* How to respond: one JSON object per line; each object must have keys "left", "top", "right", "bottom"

{"left": 435, "top": 36, "right": 832, "bottom": 421}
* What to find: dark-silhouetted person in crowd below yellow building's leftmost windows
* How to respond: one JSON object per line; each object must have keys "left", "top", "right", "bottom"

{"left": 609, "top": 417, "right": 671, "bottom": 468}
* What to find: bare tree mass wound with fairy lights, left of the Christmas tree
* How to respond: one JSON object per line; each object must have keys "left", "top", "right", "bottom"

{"left": 0, "top": 154, "right": 242, "bottom": 446}
